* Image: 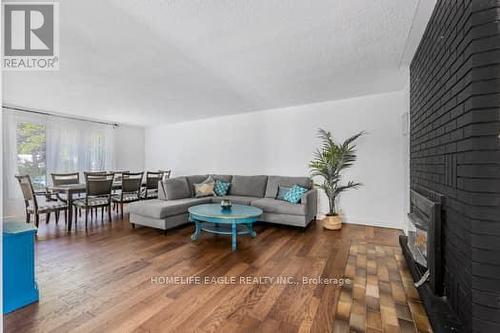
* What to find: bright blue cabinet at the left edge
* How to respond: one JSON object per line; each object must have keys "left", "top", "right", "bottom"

{"left": 2, "top": 220, "right": 38, "bottom": 314}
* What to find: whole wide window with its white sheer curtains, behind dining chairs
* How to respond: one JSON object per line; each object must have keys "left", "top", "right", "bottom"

{"left": 1, "top": 108, "right": 114, "bottom": 204}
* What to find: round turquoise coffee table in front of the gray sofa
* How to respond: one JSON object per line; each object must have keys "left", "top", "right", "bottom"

{"left": 188, "top": 204, "right": 262, "bottom": 251}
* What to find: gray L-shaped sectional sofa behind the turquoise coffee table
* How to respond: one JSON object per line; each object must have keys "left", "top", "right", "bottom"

{"left": 129, "top": 175, "right": 317, "bottom": 230}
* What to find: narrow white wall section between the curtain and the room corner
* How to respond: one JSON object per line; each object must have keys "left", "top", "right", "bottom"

{"left": 114, "top": 125, "right": 145, "bottom": 171}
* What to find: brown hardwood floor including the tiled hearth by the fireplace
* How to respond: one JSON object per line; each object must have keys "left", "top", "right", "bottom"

{"left": 4, "top": 211, "right": 430, "bottom": 332}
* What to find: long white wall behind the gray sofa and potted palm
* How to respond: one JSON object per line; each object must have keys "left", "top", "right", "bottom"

{"left": 146, "top": 92, "right": 407, "bottom": 228}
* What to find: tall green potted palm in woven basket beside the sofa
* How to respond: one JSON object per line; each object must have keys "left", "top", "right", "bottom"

{"left": 309, "top": 129, "right": 365, "bottom": 230}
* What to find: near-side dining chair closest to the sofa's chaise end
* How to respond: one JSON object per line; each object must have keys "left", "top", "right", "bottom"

{"left": 73, "top": 172, "right": 114, "bottom": 229}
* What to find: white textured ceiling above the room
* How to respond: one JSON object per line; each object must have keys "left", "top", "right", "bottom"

{"left": 3, "top": 0, "right": 427, "bottom": 126}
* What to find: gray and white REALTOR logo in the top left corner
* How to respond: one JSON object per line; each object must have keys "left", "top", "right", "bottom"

{"left": 2, "top": 2, "right": 59, "bottom": 71}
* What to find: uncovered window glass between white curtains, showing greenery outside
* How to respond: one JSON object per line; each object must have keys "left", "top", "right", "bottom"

{"left": 16, "top": 122, "right": 47, "bottom": 189}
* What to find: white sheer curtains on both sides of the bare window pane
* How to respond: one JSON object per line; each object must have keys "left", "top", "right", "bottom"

{"left": 2, "top": 109, "right": 114, "bottom": 215}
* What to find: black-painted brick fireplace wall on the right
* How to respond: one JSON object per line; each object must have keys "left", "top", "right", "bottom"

{"left": 410, "top": 0, "right": 500, "bottom": 332}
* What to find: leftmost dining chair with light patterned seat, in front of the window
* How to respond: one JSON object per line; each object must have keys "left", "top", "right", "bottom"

{"left": 15, "top": 175, "right": 68, "bottom": 227}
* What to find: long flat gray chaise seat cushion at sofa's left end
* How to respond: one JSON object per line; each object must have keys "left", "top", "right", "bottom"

{"left": 129, "top": 198, "right": 210, "bottom": 219}
